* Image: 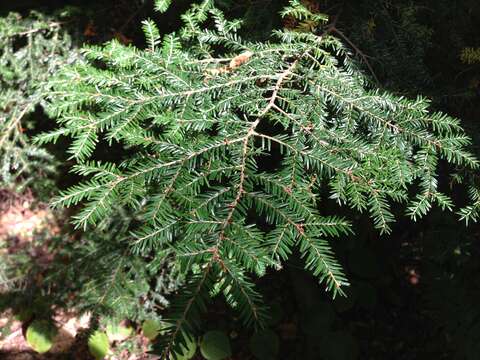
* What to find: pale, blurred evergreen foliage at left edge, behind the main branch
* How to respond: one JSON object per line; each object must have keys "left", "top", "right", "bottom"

{"left": 0, "top": 12, "right": 77, "bottom": 193}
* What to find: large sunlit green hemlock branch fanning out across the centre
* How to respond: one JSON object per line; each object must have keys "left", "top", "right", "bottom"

{"left": 38, "top": 0, "right": 478, "bottom": 358}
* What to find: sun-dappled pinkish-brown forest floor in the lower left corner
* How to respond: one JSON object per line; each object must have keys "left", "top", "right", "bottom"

{"left": 0, "top": 189, "right": 90, "bottom": 359}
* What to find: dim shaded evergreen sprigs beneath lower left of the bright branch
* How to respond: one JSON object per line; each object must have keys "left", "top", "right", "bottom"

{"left": 53, "top": 204, "right": 183, "bottom": 320}
